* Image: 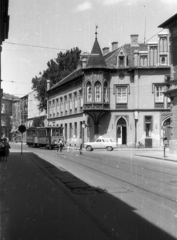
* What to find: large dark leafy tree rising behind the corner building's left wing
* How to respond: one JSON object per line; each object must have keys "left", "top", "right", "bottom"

{"left": 32, "top": 47, "right": 81, "bottom": 111}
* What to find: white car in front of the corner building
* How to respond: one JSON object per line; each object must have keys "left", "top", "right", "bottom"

{"left": 84, "top": 137, "right": 117, "bottom": 151}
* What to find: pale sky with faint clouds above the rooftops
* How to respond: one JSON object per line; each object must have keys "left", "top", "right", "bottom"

{"left": 2, "top": 0, "right": 177, "bottom": 97}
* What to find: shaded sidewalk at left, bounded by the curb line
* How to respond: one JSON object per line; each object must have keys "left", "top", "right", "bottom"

{"left": 0, "top": 152, "right": 109, "bottom": 240}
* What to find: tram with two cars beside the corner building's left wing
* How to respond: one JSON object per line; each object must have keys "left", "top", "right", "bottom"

{"left": 26, "top": 127, "right": 64, "bottom": 149}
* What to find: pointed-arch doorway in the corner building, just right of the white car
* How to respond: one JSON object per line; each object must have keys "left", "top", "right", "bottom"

{"left": 117, "top": 117, "right": 127, "bottom": 145}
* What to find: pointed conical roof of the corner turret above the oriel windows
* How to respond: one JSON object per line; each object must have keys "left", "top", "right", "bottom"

{"left": 85, "top": 38, "right": 108, "bottom": 69}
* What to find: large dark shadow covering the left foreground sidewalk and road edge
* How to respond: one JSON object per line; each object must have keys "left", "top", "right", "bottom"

{"left": 0, "top": 153, "right": 176, "bottom": 240}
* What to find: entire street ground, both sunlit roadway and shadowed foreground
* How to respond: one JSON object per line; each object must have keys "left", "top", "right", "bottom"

{"left": 0, "top": 144, "right": 177, "bottom": 240}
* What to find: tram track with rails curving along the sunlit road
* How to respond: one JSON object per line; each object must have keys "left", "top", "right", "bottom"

{"left": 32, "top": 148, "right": 177, "bottom": 205}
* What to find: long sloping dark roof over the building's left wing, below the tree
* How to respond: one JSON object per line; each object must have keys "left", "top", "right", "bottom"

{"left": 48, "top": 68, "right": 83, "bottom": 92}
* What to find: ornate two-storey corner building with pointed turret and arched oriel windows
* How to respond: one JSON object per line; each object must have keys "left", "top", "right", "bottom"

{"left": 48, "top": 32, "right": 171, "bottom": 147}
